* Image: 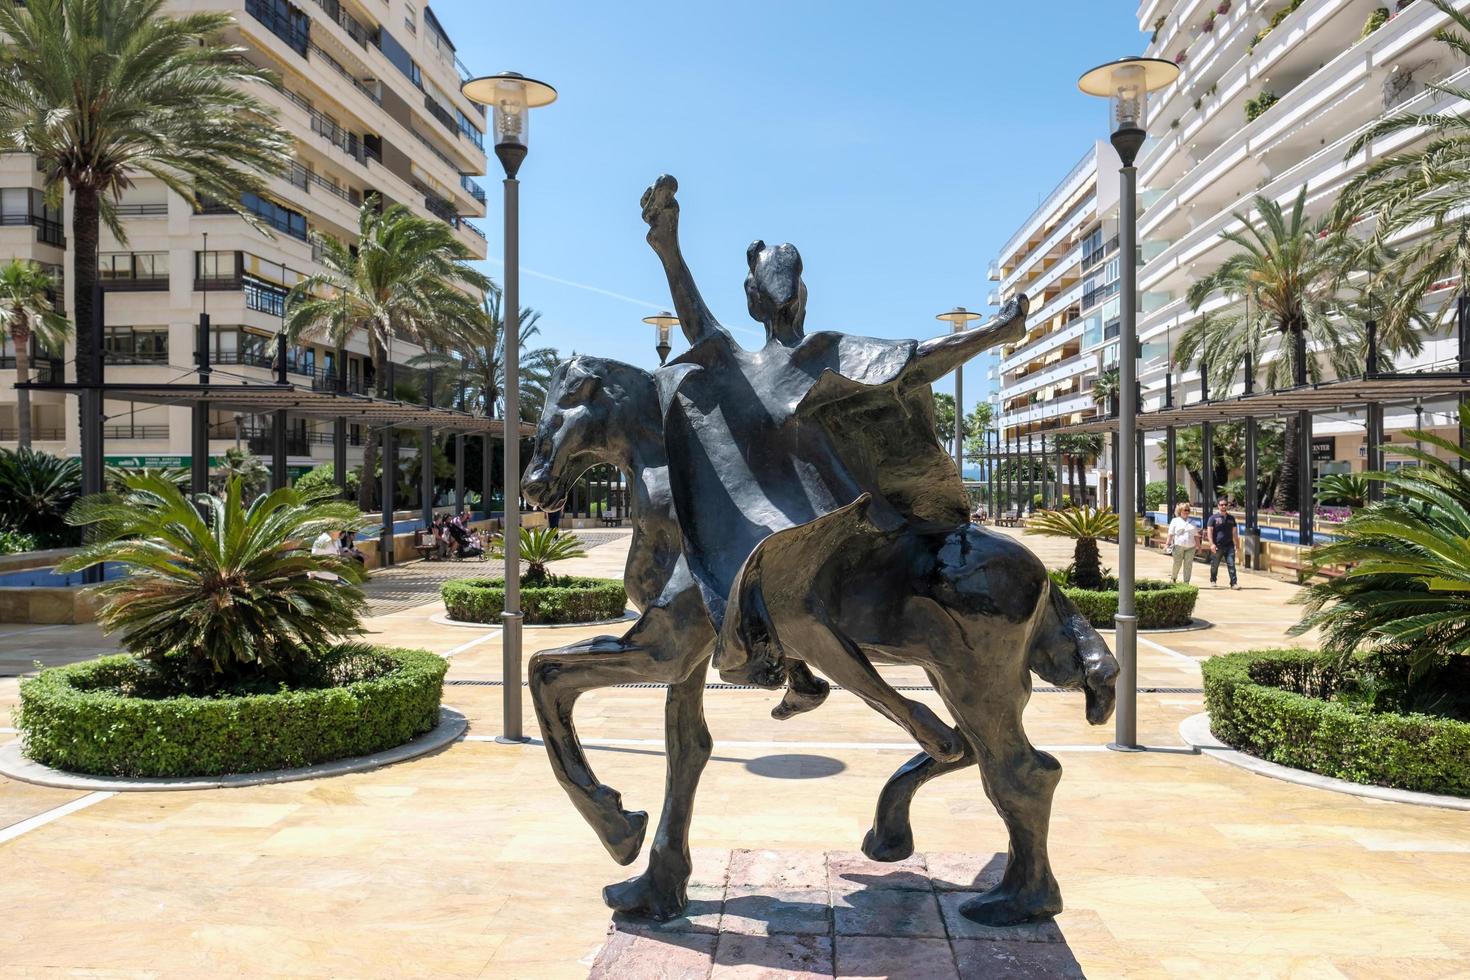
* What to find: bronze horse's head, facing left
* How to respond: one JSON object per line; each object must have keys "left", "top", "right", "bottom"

{"left": 520, "top": 354, "right": 659, "bottom": 510}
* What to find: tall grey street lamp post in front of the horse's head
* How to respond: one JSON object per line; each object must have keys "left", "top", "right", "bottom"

{"left": 460, "top": 72, "right": 556, "bottom": 742}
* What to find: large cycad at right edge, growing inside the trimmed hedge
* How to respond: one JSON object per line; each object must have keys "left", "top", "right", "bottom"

{"left": 1294, "top": 406, "right": 1470, "bottom": 696}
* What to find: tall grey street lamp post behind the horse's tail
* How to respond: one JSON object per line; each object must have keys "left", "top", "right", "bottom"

{"left": 1078, "top": 57, "right": 1179, "bottom": 752}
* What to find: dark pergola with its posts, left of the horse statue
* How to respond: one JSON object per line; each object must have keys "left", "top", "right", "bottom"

{"left": 25, "top": 372, "right": 535, "bottom": 575}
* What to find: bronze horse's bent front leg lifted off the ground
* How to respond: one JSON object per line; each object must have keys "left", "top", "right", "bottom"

{"left": 529, "top": 605, "right": 709, "bottom": 864}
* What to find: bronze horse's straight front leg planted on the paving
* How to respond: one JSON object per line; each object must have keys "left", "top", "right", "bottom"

{"left": 603, "top": 658, "right": 713, "bottom": 920}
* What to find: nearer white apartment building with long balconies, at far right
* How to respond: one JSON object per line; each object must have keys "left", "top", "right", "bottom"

{"left": 992, "top": 0, "right": 1470, "bottom": 502}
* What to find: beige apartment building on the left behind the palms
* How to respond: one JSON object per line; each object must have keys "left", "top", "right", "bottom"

{"left": 0, "top": 0, "right": 487, "bottom": 473}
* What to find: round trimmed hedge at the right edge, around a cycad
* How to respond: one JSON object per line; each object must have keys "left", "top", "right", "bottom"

{"left": 1204, "top": 649, "right": 1470, "bottom": 796}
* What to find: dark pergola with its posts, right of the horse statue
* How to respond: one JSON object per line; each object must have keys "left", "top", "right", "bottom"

{"left": 972, "top": 372, "right": 1470, "bottom": 545}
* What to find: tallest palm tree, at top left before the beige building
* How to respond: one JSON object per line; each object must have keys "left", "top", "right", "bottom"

{"left": 0, "top": 0, "right": 291, "bottom": 411}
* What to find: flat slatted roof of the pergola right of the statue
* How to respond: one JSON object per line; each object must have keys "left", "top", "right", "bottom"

{"left": 1032, "top": 372, "right": 1470, "bottom": 435}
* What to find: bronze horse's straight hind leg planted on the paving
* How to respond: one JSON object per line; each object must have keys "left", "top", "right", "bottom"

{"left": 941, "top": 666, "right": 1061, "bottom": 926}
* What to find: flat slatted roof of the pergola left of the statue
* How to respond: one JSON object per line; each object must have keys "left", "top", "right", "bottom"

{"left": 16, "top": 382, "right": 537, "bottom": 436}
